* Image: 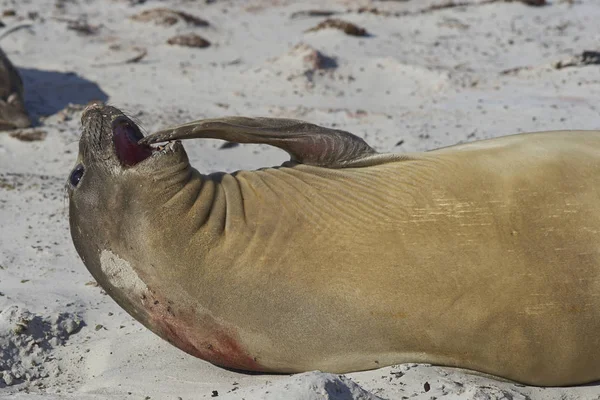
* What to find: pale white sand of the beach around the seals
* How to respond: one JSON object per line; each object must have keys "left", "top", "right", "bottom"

{"left": 0, "top": 0, "right": 600, "bottom": 400}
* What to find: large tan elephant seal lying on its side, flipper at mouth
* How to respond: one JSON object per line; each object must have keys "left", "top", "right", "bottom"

{"left": 68, "top": 104, "right": 600, "bottom": 386}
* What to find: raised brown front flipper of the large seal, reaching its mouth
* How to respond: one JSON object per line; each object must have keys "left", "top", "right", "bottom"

{"left": 139, "top": 117, "right": 377, "bottom": 168}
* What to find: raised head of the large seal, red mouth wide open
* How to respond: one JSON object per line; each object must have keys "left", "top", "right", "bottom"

{"left": 67, "top": 103, "right": 190, "bottom": 290}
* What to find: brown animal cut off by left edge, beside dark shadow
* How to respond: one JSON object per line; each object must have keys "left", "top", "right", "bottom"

{"left": 0, "top": 49, "right": 31, "bottom": 130}
